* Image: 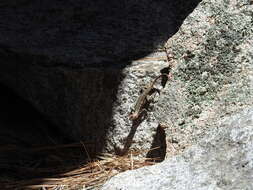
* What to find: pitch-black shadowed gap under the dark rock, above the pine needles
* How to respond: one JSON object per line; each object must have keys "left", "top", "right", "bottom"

{"left": 0, "top": 85, "right": 87, "bottom": 189}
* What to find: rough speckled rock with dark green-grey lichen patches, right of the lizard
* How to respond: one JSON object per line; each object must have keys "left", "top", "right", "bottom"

{"left": 154, "top": 0, "right": 253, "bottom": 156}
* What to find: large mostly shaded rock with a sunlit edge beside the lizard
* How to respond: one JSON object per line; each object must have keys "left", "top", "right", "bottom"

{"left": 0, "top": 0, "right": 202, "bottom": 152}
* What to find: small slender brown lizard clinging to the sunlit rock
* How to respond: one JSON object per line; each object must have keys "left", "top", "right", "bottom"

{"left": 129, "top": 74, "right": 169, "bottom": 121}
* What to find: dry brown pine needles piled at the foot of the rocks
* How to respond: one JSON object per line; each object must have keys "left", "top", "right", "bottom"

{"left": 3, "top": 142, "right": 160, "bottom": 190}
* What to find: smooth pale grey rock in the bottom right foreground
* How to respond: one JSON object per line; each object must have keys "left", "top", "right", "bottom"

{"left": 102, "top": 108, "right": 253, "bottom": 190}
